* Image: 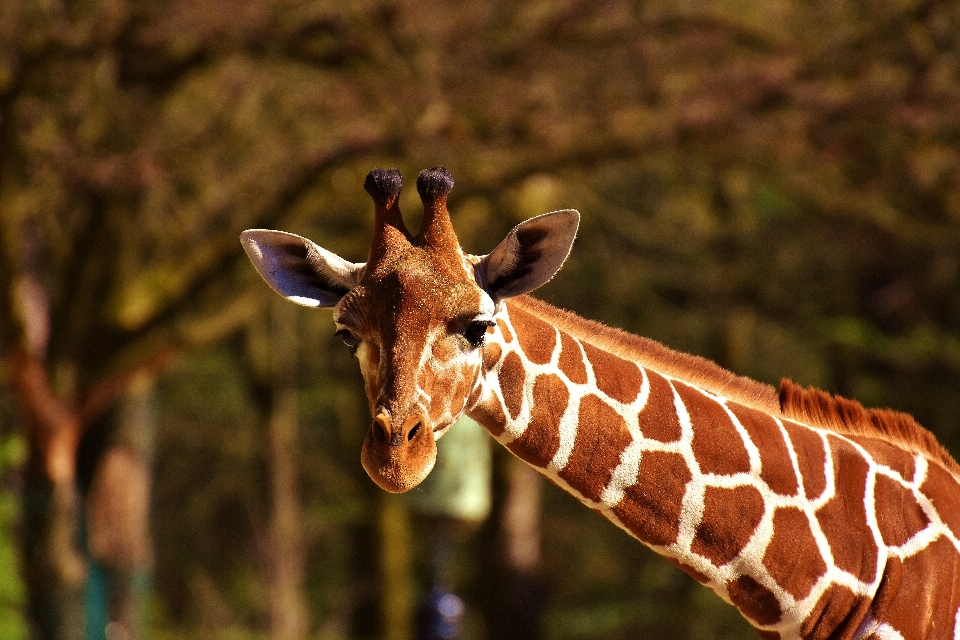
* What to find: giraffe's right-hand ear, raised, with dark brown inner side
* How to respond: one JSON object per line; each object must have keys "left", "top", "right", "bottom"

{"left": 476, "top": 209, "right": 580, "bottom": 304}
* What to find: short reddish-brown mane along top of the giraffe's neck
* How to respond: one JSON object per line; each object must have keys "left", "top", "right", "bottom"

{"left": 510, "top": 296, "right": 960, "bottom": 476}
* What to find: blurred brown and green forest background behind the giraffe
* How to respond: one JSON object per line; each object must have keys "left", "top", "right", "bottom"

{"left": 0, "top": 0, "right": 960, "bottom": 640}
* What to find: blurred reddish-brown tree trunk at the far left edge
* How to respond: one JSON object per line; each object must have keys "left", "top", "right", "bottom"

{"left": 7, "top": 194, "right": 86, "bottom": 640}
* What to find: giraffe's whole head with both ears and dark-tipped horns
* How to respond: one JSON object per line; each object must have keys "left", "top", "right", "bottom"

{"left": 242, "top": 168, "right": 580, "bottom": 492}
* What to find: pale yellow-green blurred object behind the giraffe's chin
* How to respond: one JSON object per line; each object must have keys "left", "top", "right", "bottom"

{"left": 406, "top": 416, "right": 491, "bottom": 522}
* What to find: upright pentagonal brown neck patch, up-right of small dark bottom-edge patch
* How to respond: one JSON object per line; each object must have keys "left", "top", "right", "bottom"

{"left": 763, "top": 507, "right": 827, "bottom": 600}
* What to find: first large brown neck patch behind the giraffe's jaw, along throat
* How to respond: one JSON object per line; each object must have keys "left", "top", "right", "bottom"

{"left": 507, "top": 374, "right": 570, "bottom": 468}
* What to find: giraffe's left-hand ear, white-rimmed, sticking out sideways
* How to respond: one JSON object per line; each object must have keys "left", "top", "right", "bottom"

{"left": 240, "top": 229, "right": 365, "bottom": 307}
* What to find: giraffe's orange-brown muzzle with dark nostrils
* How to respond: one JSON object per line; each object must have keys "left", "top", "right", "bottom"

{"left": 360, "top": 411, "right": 437, "bottom": 493}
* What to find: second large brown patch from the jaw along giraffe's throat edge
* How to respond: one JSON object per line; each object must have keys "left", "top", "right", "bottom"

{"left": 560, "top": 395, "right": 633, "bottom": 501}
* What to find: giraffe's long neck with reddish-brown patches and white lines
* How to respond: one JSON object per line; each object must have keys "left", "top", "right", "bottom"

{"left": 468, "top": 298, "right": 960, "bottom": 638}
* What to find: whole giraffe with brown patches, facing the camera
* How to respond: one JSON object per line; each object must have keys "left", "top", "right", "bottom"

{"left": 242, "top": 167, "right": 960, "bottom": 640}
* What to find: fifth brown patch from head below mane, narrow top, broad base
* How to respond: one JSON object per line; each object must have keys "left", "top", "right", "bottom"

{"left": 674, "top": 382, "right": 750, "bottom": 475}
